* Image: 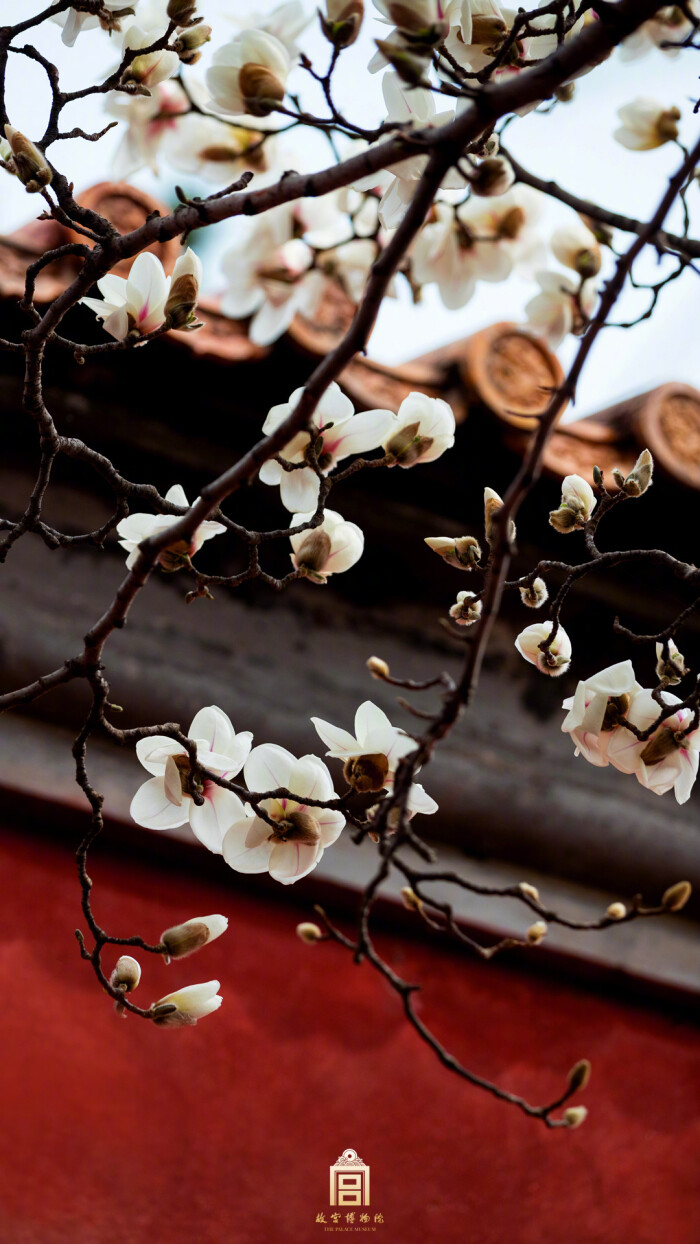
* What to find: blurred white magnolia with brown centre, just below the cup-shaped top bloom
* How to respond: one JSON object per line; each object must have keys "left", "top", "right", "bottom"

{"left": 165, "top": 112, "right": 272, "bottom": 185}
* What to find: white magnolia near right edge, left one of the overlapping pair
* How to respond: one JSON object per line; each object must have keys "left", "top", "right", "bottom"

{"left": 562, "top": 661, "right": 642, "bottom": 768}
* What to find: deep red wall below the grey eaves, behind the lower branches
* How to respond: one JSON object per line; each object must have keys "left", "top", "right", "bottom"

{"left": 0, "top": 832, "right": 700, "bottom": 1244}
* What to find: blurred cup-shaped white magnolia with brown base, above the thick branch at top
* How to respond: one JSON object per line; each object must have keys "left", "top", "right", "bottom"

{"left": 206, "top": 30, "right": 291, "bottom": 117}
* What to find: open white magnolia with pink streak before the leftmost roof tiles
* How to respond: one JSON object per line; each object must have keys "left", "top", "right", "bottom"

{"left": 81, "top": 246, "right": 201, "bottom": 341}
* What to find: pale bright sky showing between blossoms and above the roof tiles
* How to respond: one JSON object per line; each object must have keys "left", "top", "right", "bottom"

{"left": 0, "top": 0, "right": 700, "bottom": 417}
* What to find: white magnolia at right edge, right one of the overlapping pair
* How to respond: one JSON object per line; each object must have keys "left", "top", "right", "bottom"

{"left": 608, "top": 690, "right": 700, "bottom": 804}
